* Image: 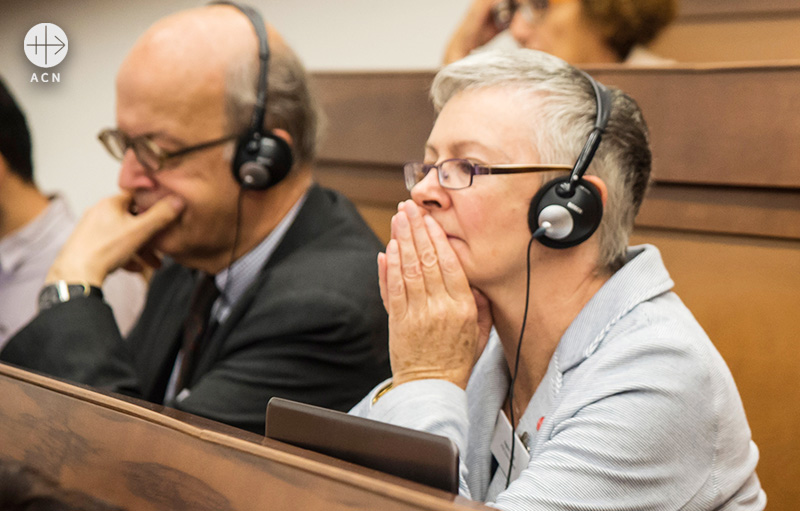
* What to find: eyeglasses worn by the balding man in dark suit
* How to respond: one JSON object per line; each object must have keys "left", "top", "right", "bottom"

{"left": 97, "top": 129, "right": 237, "bottom": 172}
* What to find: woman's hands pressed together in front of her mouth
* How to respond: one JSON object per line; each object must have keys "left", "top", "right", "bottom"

{"left": 378, "top": 201, "right": 492, "bottom": 388}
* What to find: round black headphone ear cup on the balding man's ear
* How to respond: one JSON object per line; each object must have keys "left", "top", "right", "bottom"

{"left": 233, "top": 133, "right": 293, "bottom": 190}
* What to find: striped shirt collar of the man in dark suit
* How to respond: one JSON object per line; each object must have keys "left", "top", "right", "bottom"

{"left": 211, "top": 192, "right": 308, "bottom": 323}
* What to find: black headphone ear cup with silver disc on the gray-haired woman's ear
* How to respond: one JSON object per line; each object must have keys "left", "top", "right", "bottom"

{"left": 528, "top": 177, "right": 603, "bottom": 248}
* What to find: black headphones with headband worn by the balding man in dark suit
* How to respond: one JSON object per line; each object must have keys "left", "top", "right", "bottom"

{"left": 216, "top": 2, "right": 293, "bottom": 190}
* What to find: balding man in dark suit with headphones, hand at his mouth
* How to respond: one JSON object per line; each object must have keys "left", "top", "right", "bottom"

{"left": 2, "top": 5, "right": 389, "bottom": 433}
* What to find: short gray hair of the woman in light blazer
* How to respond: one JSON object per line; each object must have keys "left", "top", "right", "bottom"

{"left": 431, "top": 49, "right": 652, "bottom": 272}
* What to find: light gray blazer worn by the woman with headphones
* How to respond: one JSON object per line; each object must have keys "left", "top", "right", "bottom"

{"left": 351, "top": 245, "right": 766, "bottom": 511}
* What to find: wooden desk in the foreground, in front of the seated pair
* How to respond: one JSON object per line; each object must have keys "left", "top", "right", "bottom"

{"left": 0, "top": 364, "right": 487, "bottom": 511}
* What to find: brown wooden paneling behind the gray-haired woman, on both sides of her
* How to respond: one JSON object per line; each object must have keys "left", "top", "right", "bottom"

{"left": 314, "top": 62, "right": 800, "bottom": 511}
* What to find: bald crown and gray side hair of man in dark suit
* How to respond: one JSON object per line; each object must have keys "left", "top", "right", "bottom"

{"left": 117, "top": 5, "right": 319, "bottom": 168}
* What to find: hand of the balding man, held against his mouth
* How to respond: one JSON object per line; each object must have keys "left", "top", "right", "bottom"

{"left": 46, "top": 194, "right": 184, "bottom": 286}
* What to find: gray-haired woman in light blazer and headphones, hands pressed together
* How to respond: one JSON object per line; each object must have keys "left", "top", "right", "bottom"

{"left": 352, "top": 50, "right": 765, "bottom": 510}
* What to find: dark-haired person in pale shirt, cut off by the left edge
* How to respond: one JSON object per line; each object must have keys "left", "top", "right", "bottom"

{"left": 0, "top": 79, "right": 146, "bottom": 351}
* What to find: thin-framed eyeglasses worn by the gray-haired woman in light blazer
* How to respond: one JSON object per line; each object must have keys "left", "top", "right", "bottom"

{"left": 403, "top": 158, "right": 572, "bottom": 191}
